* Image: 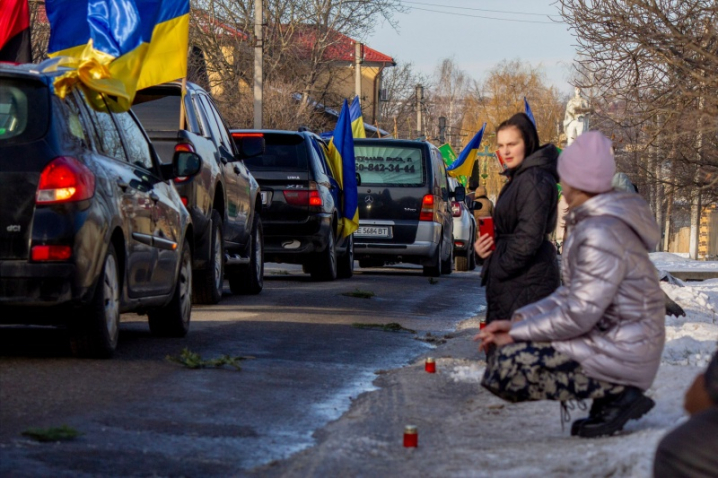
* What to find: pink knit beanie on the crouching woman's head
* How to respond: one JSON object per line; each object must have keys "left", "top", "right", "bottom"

{"left": 558, "top": 131, "right": 616, "bottom": 194}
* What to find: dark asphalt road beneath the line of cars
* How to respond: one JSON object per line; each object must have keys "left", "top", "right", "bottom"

{"left": 0, "top": 264, "right": 485, "bottom": 477}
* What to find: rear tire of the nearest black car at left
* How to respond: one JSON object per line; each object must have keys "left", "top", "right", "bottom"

{"left": 68, "top": 244, "right": 122, "bottom": 358}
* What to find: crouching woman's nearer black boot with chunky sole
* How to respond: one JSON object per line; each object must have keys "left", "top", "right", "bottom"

{"left": 571, "top": 387, "right": 656, "bottom": 438}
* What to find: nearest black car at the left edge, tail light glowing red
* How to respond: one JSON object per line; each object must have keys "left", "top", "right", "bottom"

{"left": 0, "top": 64, "right": 201, "bottom": 357}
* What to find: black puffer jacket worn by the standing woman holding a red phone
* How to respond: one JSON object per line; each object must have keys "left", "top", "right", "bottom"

{"left": 482, "top": 144, "right": 560, "bottom": 322}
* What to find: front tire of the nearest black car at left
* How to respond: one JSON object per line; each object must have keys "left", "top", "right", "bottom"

{"left": 147, "top": 239, "right": 192, "bottom": 337}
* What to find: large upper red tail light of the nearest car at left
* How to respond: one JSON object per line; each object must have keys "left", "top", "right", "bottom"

{"left": 35, "top": 156, "right": 95, "bottom": 204}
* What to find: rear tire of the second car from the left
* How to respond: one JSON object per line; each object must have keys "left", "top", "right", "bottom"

{"left": 192, "top": 210, "right": 224, "bottom": 304}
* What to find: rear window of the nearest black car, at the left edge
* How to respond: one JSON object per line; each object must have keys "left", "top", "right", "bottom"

{"left": 0, "top": 78, "right": 50, "bottom": 146}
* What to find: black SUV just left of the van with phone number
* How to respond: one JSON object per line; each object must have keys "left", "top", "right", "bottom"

{"left": 232, "top": 130, "right": 354, "bottom": 280}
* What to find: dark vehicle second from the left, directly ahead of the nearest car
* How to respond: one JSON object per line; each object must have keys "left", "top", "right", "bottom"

{"left": 132, "top": 82, "right": 264, "bottom": 304}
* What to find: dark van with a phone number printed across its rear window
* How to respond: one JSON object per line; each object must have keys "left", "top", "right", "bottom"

{"left": 354, "top": 139, "right": 466, "bottom": 277}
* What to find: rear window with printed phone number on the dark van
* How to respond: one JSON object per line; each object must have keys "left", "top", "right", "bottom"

{"left": 354, "top": 145, "right": 426, "bottom": 186}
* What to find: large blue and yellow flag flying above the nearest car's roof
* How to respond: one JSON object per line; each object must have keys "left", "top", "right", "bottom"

{"left": 45, "top": 0, "right": 189, "bottom": 111}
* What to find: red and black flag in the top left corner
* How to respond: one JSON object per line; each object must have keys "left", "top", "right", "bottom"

{"left": 0, "top": 0, "right": 32, "bottom": 63}
